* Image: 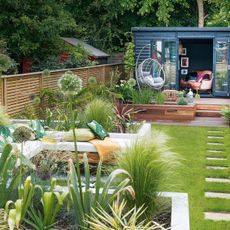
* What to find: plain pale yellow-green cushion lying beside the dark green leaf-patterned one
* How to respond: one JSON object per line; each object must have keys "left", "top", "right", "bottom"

{"left": 62, "top": 129, "right": 95, "bottom": 141}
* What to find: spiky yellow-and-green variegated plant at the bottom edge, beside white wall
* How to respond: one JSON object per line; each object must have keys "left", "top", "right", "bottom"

{"left": 87, "top": 200, "right": 166, "bottom": 230}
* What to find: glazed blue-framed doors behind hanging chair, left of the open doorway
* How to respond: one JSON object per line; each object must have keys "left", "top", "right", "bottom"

{"left": 152, "top": 39, "right": 177, "bottom": 89}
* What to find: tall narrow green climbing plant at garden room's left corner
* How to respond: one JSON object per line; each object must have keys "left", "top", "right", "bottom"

{"left": 124, "top": 42, "right": 135, "bottom": 78}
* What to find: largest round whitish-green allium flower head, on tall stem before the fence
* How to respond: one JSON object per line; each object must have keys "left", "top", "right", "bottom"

{"left": 58, "top": 71, "right": 82, "bottom": 95}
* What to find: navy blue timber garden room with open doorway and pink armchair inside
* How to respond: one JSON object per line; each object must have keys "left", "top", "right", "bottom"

{"left": 132, "top": 27, "right": 230, "bottom": 98}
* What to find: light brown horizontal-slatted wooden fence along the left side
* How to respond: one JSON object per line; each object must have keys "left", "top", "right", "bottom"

{"left": 0, "top": 64, "right": 124, "bottom": 115}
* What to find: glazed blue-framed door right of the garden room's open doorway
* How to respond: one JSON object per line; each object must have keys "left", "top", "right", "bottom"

{"left": 214, "top": 39, "right": 230, "bottom": 96}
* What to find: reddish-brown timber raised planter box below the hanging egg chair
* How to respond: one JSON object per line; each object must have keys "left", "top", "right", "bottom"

{"left": 128, "top": 104, "right": 196, "bottom": 121}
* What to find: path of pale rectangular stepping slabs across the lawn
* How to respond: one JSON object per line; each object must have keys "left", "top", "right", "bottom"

{"left": 204, "top": 128, "right": 230, "bottom": 221}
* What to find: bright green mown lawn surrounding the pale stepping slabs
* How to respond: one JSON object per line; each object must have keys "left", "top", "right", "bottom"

{"left": 153, "top": 125, "right": 230, "bottom": 230}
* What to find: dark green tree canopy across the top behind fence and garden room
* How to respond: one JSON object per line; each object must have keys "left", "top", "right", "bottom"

{"left": 0, "top": 0, "right": 230, "bottom": 71}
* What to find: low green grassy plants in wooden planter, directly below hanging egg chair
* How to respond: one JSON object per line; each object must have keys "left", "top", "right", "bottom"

{"left": 132, "top": 88, "right": 155, "bottom": 104}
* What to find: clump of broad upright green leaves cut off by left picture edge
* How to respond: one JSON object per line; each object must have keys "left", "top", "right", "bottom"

{"left": 0, "top": 144, "right": 19, "bottom": 208}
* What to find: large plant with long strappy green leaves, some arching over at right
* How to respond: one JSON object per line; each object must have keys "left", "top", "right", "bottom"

{"left": 68, "top": 154, "right": 134, "bottom": 228}
